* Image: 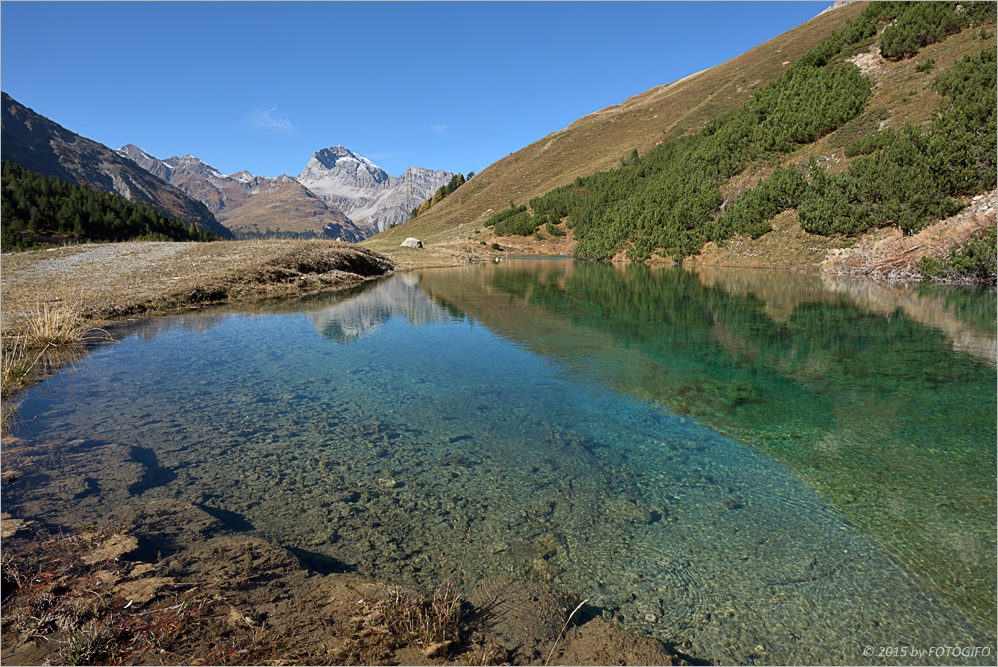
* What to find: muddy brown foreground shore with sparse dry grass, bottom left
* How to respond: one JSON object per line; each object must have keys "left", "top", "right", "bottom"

{"left": 3, "top": 499, "right": 701, "bottom": 665}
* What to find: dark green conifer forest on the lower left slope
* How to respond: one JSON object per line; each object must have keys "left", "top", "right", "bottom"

{"left": 0, "top": 161, "right": 215, "bottom": 252}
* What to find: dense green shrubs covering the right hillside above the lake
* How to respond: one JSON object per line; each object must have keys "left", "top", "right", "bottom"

{"left": 508, "top": 2, "right": 995, "bottom": 260}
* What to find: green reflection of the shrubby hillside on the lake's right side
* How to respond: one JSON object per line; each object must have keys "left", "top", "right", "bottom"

{"left": 421, "top": 261, "right": 996, "bottom": 627}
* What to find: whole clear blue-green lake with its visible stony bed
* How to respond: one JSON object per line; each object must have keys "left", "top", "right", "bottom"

{"left": 4, "top": 260, "right": 996, "bottom": 664}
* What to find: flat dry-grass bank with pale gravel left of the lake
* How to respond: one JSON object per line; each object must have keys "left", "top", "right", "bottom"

{"left": 0, "top": 241, "right": 393, "bottom": 335}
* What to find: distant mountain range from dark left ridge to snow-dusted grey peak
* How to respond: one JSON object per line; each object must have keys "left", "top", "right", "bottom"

{"left": 0, "top": 93, "right": 454, "bottom": 242}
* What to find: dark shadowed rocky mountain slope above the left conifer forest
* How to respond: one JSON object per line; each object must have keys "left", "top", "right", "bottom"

{"left": 0, "top": 93, "right": 232, "bottom": 238}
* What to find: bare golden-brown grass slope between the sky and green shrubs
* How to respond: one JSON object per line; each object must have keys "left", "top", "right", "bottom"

{"left": 365, "top": 3, "right": 866, "bottom": 246}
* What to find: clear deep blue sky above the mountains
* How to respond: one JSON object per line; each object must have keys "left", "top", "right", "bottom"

{"left": 0, "top": 1, "right": 831, "bottom": 176}
